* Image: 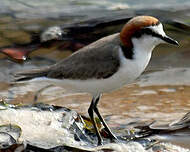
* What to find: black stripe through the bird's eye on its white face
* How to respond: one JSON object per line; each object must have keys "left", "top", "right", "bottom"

{"left": 133, "top": 28, "right": 162, "bottom": 38}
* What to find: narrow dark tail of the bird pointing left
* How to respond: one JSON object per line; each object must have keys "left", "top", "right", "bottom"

{"left": 13, "top": 68, "right": 49, "bottom": 82}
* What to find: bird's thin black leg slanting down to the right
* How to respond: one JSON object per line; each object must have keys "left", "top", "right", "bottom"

{"left": 94, "top": 95, "right": 118, "bottom": 141}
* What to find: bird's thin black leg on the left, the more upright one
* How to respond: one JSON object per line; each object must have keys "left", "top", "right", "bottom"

{"left": 88, "top": 96, "right": 102, "bottom": 145}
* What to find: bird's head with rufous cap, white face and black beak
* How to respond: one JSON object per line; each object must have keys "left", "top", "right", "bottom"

{"left": 120, "top": 16, "right": 178, "bottom": 50}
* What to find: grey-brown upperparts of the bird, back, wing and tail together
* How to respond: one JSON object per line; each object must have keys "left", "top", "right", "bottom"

{"left": 15, "top": 34, "right": 120, "bottom": 81}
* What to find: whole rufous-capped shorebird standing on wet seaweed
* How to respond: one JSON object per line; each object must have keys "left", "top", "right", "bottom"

{"left": 15, "top": 16, "right": 178, "bottom": 145}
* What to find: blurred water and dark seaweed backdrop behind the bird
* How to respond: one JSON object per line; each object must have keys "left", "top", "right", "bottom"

{"left": 0, "top": 0, "right": 190, "bottom": 133}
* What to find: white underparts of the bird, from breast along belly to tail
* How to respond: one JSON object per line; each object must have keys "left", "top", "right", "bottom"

{"left": 33, "top": 46, "right": 151, "bottom": 95}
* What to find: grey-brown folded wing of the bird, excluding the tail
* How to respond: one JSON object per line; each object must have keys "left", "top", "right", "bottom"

{"left": 47, "top": 34, "right": 120, "bottom": 80}
